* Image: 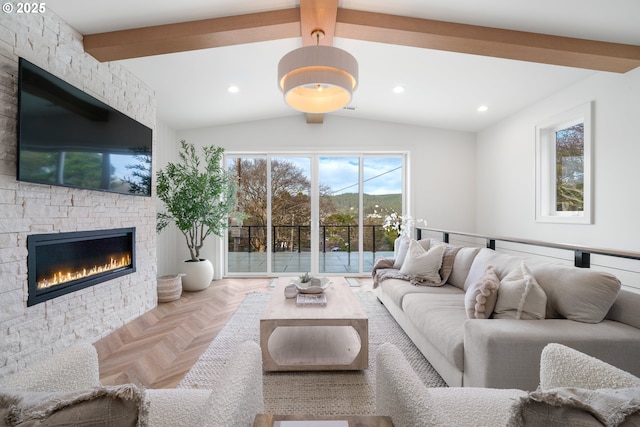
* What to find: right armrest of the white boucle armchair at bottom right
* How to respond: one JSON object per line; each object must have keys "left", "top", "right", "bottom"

{"left": 540, "top": 343, "right": 640, "bottom": 390}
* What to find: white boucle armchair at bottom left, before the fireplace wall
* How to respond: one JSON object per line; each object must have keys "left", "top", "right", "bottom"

{"left": 0, "top": 341, "right": 264, "bottom": 427}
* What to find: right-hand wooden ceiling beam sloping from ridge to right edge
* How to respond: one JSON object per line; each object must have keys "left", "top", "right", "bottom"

{"left": 336, "top": 9, "right": 640, "bottom": 73}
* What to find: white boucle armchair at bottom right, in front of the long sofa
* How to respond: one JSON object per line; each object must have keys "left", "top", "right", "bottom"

{"left": 376, "top": 343, "right": 640, "bottom": 427}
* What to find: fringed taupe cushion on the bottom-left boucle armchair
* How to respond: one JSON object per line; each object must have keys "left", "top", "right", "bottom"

{"left": 0, "top": 384, "right": 148, "bottom": 427}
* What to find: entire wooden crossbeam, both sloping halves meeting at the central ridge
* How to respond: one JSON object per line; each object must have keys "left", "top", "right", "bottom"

{"left": 84, "top": 6, "right": 640, "bottom": 73}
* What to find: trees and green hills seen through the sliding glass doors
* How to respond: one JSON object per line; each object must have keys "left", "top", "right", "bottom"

{"left": 229, "top": 158, "right": 402, "bottom": 252}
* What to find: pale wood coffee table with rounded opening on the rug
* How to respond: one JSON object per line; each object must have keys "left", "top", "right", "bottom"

{"left": 260, "top": 277, "right": 369, "bottom": 371}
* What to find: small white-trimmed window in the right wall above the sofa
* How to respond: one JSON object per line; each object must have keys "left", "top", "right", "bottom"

{"left": 536, "top": 102, "right": 592, "bottom": 224}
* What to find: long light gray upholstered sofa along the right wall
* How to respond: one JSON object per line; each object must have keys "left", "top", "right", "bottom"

{"left": 373, "top": 239, "right": 640, "bottom": 390}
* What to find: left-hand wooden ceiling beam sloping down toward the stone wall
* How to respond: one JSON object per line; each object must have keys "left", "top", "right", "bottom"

{"left": 83, "top": 7, "right": 300, "bottom": 62}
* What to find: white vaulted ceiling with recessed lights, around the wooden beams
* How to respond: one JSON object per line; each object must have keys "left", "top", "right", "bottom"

{"left": 46, "top": 0, "right": 640, "bottom": 132}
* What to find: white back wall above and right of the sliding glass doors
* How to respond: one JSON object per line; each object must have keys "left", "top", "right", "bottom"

{"left": 168, "top": 114, "right": 476, "bottom": 277}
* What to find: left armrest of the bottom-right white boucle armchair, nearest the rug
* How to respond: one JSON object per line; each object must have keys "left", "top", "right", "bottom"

{"left": 376, "top": 343, "right": 436, "bottom": 427}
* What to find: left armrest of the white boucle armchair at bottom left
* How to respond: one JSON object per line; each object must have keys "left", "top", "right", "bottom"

{"left": 0, "top": 343, "right": 100, "bottom": 392}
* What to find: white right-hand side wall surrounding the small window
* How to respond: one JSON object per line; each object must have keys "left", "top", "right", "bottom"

{"left": 476, "top": 69, "right": 640, "bottom": 251}
